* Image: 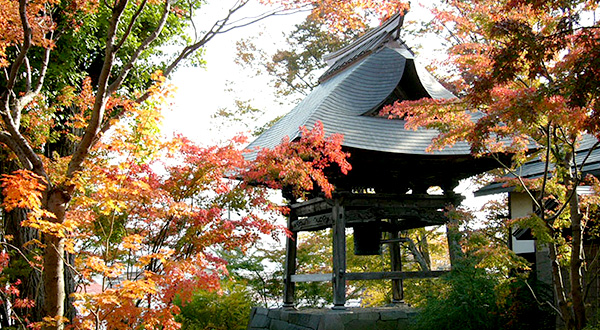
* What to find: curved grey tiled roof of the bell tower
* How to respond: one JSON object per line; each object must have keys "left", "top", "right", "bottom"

{"left": 241, "top": 15, "right": 470, "bottom": 159}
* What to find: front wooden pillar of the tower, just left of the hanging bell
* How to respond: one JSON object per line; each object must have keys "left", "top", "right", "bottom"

{"left": 332, "top": 199, "right": 346, "bottom": 309}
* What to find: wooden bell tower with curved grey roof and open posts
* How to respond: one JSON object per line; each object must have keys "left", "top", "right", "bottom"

{"left": 247, "top": 9, "right": 497, "bottom": 309}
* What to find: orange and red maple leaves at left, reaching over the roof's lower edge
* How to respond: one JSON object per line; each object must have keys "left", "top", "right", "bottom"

{"left": 2, "top": 84, "right": 349, "bottom": 329}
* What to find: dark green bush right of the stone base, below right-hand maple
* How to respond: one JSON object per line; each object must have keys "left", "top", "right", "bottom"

{"left": 414, "top": 255, "right": 556, "bottom": 330}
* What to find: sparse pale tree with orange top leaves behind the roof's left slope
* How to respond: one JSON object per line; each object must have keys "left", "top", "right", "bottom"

{"left": 218, "top": 0, "right": 408, "bottom": 135}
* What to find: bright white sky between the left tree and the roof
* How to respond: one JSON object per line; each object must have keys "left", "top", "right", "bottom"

{"left": 163, "top": 1, "right": 306, "bottom": 144}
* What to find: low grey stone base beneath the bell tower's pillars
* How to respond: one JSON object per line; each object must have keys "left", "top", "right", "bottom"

{"left": 248, "top": 306, "right": 416, "bottom": 330}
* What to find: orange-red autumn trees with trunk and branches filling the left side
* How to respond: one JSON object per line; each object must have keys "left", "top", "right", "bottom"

{"left": 0, "top": 0, "right": 366, "bottom": 329}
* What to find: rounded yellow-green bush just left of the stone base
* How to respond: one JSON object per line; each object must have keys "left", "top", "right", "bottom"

{"left": 175, "top": 282, "right": 254, "bottom": 330}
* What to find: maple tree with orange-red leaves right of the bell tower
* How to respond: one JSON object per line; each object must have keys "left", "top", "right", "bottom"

{"left": 382, "top": 0, "right": 600, "bottom": 329}
